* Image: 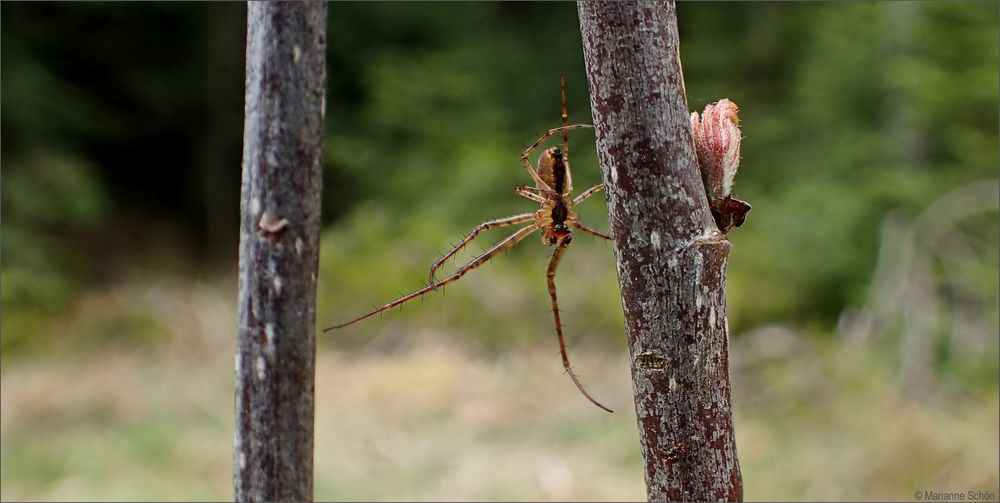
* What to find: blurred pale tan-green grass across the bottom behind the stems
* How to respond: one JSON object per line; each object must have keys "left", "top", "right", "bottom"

{"left": 0, "top": 281, "right": 1000, "bottom": 501}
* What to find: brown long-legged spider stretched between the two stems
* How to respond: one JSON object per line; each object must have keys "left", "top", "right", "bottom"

{"left": 323, "top": 76, "right": 612, "bottom": 412}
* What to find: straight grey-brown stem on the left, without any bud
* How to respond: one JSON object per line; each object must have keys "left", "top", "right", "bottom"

{"left": 233, "top": 2, "right": 326, "bottom": 501}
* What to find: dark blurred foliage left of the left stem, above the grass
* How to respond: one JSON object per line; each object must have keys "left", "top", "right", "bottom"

{"left": 0, "top": 2, "right": 245, "bottom": 352}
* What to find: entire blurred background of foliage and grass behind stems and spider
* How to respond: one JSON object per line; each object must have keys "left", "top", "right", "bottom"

{"left": 0, "top": 2, "right": 1000, "bottom": 500}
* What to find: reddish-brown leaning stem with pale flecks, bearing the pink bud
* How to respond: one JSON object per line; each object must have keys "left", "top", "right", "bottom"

{"left": 577, "top": 1, "right": 743, "bottom": 501}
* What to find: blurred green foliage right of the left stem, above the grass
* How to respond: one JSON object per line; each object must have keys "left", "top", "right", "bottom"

{"left": 320, "top": 3, "right": 1000, "bottom": 390}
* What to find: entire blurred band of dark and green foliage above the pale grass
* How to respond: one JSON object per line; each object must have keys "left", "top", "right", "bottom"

{"left": 0, "top": 3, "right": 998, "bottom": 366}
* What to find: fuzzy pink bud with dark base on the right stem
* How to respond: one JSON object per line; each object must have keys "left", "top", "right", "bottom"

{"left": 691, "top": 98, "right": 750, "bottom": 232}
